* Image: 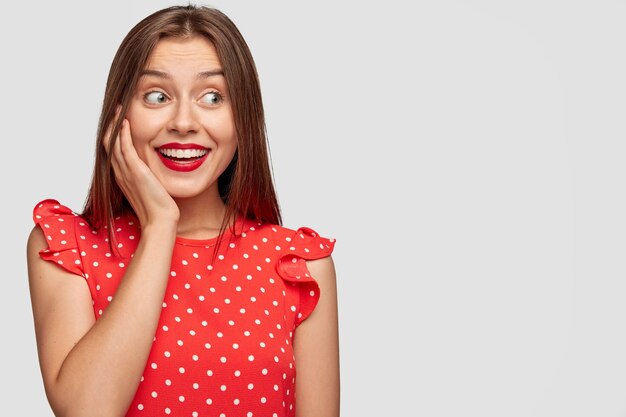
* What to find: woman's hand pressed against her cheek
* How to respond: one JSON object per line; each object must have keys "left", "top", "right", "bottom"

{"left": 104, "top": 109, "right": 180, "bottom": 227}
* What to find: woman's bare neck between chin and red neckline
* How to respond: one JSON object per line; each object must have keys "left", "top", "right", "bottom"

{"left": 174, "top": 190, "right": 226, "bottom": 239}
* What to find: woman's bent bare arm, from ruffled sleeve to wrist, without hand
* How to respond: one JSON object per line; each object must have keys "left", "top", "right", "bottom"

{"left": 27, "top": 225, "right": 176, "bottom": 417}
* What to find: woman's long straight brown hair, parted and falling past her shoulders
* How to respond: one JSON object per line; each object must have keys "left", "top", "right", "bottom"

{"left": 82, "top": 5, "right": 281, "bottom": 242}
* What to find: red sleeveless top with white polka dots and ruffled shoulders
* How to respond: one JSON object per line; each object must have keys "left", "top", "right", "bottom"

{"left": 34, "top": 200, "right": 334, "bottom": 417}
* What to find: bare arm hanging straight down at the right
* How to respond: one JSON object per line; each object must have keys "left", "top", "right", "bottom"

{"left": 294, "top": 256, "right": 339, "bottom": 417}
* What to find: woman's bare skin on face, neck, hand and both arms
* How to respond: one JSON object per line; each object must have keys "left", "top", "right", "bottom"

{"left": 28, "top": 38, "right": 339, "bottom": 417}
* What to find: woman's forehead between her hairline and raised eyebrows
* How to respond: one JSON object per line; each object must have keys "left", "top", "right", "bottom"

{"left": 146, "top": 36, "right": 222, "bottom": 70}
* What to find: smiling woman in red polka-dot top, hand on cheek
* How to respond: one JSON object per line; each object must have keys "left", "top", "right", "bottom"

{"left": 28, "top": 6, "right": 339, "bottom": 417}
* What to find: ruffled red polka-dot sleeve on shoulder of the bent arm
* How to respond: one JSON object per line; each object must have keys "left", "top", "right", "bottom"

{"left": 33, "top": 199, "right": 85, "bottom": 277}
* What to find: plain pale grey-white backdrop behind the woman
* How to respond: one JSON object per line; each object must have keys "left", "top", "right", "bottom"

{"left": 0, "top": 0, "right": 626, "bottom": 417}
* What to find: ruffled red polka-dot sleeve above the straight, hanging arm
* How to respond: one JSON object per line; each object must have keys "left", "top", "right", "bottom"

{"left": 276, "top": 227, "right": 335, "bottom": 326}
